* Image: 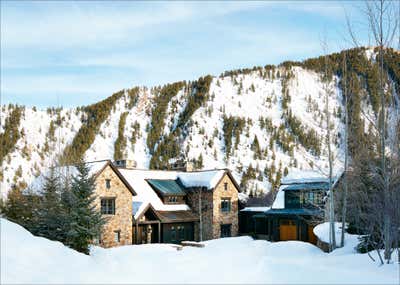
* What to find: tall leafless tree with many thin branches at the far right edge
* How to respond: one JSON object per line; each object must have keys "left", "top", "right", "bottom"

{"left": 346, "top": 0, "right": 400, "bottom": 262}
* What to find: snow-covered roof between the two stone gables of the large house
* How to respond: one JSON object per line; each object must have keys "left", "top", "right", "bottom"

{"left": 118, "top": 169, "right": 225, "bottom": 219}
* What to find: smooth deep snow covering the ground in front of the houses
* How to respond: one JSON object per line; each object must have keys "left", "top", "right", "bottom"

{"left": 0, "top": 219, "right": 399, "bottom": 284}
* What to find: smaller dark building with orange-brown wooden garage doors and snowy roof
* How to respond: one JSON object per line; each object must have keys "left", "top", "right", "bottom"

{"left": 253, "top": 172, "right": 338, "bottom": 244}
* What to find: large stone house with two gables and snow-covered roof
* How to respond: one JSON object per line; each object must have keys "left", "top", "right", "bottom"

{"left": 49, "top": 160, "right": 239, "bottom": 247}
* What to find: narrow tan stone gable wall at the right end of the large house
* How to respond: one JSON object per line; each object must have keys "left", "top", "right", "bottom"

{"left": 212, "top": 174, "right": 239, "bottom": 238}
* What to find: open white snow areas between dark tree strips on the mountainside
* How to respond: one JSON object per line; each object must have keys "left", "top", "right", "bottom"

{"left": 0, "top": 49, "right": 384, "bottom": 196}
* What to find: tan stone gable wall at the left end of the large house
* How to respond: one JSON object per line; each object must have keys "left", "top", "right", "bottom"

{"left": 95, "top": 165, "right": 132, "bottom": 247}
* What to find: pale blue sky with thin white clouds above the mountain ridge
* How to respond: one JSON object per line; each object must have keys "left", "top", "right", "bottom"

{"left": 1, "top": 1, "right": 365, "bottom": 107}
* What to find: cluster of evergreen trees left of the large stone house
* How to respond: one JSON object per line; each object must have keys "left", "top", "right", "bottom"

{"left": 0, "top": 162, "right": 105, "bottom": 254}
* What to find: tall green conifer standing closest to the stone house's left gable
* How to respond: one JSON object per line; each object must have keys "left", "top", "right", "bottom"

{"left": 66, "top": 162, "right": 105, "bottom": 254}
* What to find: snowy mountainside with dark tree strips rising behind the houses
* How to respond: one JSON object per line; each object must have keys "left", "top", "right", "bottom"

{"left": 0, "top": 48, "right": 400, "bottom": 196}
